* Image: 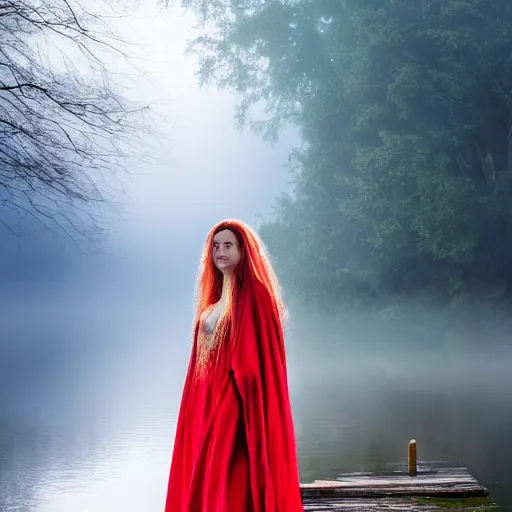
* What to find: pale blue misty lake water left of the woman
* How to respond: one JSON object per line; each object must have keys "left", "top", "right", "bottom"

{"left": 0, "top": 280, "right": 191, "bottom": 511}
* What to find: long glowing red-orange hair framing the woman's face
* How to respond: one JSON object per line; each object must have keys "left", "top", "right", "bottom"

{"left": 195, "top": 219, "right": 286, "bottom": 334}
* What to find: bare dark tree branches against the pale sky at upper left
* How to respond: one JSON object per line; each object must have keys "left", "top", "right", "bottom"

{"left": 0, "top": 0, "right": 147, "bottom": 252}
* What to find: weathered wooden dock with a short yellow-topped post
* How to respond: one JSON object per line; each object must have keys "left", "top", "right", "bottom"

{"left": 301, "top": 445, "right": 498, "bottom": 512}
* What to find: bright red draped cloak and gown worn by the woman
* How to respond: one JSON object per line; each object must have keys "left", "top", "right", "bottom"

{"left": 165, "top": 281, "right": 303, "bottom": 512}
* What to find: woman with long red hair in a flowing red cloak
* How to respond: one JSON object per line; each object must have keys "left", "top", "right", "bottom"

{"left": 165, "top": 220, "right": 303, "bottom": 512}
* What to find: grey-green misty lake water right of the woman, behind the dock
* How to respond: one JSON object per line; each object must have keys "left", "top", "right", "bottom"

{"left": 289, "top": 306, "right": 512, "bottom": 507}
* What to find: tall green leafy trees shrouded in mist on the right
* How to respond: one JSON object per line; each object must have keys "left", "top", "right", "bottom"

{"left": 183, "top": 0, "right": 512, "bottom": 301}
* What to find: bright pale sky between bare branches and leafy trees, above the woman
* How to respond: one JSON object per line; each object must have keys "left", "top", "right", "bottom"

{"left": 101, "top": 1, "right": 296, "bottom": 266}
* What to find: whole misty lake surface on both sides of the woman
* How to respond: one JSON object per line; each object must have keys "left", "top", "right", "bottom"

{"left": 0, "top": 286, "right": 512, "bottom": 512}
